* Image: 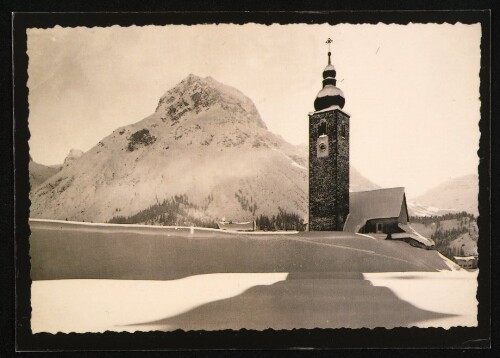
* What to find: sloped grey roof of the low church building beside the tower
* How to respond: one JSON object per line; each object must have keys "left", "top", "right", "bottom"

{"left": 344, "top": 188, "right": 405, "bottom": 232}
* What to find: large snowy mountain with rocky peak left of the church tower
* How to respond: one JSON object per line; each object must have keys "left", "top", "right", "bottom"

{"left": 31, "top": 75, "right": 307, "bottom": 222}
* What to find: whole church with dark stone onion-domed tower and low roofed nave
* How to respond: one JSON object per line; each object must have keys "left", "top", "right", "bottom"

{"left": 309, "top": 39, "right": 434, "bottom": 247}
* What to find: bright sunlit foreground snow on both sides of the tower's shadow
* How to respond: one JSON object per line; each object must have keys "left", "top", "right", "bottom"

{"left": 31, "top": 270, "right": 477, "bottom": 333}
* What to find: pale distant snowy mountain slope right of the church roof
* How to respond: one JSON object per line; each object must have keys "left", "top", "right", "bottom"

{"left": 408, "top": 174, "right": 479, "bottom": 216}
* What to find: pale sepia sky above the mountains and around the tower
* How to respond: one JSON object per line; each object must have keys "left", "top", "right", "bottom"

{"left": 28, "top": 24, "right": 481, "bottom": 198}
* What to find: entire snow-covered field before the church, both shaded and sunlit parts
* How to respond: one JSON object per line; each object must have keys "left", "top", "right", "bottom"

{"left": 30, "top": 221, "right": 477, "bottom": 333}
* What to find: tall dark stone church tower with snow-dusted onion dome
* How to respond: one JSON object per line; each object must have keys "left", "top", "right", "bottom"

{"left": 309, "top": 39, "right": 349, "bottom": 231}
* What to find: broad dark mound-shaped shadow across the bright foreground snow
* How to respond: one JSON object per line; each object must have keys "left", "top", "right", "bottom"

{"left": 126, "top": 272, "right": 452, "bottom": 331}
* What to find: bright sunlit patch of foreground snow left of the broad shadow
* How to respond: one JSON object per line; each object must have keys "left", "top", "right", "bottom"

{"left": 31, "top": 273, "right": 287, "bottom": 333}
